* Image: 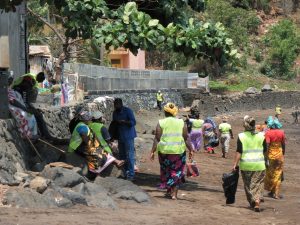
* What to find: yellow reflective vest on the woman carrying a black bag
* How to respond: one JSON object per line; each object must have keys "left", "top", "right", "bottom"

{"left": 239, "top": 131, "right": 266, "bottom": 171}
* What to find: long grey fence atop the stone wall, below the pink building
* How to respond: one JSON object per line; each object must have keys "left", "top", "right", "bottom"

{"left": 64, "top": 63, "right": 208, "bottom": 91}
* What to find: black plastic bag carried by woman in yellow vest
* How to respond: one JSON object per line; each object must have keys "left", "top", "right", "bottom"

{"left": 222, "top": 167, "right": 239, "bottom": 204}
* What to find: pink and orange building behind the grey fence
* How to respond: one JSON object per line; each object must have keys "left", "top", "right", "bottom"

{"left": 108, "top": 48, "right": 145, "bottom": 70}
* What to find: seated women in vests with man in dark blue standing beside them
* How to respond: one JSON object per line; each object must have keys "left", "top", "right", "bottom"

{"left": 68, "top": 98, "right": 136, "bottom": 181}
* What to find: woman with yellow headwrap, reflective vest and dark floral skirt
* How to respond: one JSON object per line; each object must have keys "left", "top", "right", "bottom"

{"left": 150, "top": 103, "right": 193, "bottom": 200}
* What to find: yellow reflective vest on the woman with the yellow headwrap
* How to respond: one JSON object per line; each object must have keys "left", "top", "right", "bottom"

{"left": 157, "top": 117, "right": 185, "bottom": 154}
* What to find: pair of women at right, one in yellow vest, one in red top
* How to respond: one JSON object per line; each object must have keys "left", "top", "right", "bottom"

{"left": 233, "top": 116, "right": 285, "bottom": 212}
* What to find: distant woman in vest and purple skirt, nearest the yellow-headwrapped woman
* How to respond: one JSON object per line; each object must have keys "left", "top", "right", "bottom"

{"left": 188, "top": 113, "right": 204, "bottom": 152}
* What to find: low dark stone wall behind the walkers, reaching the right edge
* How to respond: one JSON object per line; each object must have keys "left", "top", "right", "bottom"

{"left": 192, "top": 91, "right": 300, "bottom": 116}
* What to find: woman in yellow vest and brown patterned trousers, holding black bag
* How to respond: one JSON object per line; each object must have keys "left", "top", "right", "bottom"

{"left": 233, "top": 116, "right": 267, "bottom": 212}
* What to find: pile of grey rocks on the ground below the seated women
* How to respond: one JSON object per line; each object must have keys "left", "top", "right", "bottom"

{"left": 2, "top": 165, "right": 151, "bottom": 209}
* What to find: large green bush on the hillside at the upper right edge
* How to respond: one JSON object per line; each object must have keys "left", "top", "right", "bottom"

{"left": 262, "top": 20, "right": 300, "bottom": 79}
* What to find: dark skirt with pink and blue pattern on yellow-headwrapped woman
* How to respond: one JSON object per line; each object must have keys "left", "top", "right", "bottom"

{"left": 158, "top": 152, "right": 186, "bottom": 192}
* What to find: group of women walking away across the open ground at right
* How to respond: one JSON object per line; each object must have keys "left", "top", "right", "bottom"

{"left": 150, "top": 100, "right": 285, "bottom": 212}
